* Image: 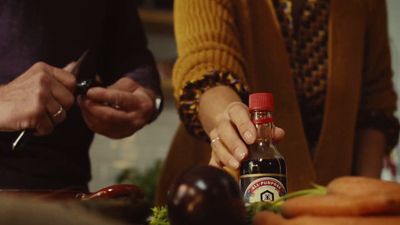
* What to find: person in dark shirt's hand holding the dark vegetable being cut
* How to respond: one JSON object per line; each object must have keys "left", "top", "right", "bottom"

{"left": 78, "top": 77, "right": 155, "bottom": 138}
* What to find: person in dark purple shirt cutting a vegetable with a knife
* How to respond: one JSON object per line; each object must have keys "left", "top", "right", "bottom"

{"left": 0, "top": 0, "right": 161, "bottom": 191}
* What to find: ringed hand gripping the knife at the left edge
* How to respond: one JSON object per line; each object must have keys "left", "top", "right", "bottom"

{"left": 0, "top": 62, "right": 76, "bottom": 135}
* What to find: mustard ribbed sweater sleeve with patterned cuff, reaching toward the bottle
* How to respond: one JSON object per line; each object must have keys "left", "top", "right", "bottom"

{"left": 173, "top": 0, "right": 247, "bottom": 139}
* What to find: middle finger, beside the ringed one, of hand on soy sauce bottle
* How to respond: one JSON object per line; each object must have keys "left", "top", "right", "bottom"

{"left": 217, "top": 120, "right": 247, "bottom": 161}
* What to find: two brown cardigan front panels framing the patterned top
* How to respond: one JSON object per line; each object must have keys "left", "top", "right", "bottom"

{"left": 233, "top": 0, "right": 366, "bottom": 189}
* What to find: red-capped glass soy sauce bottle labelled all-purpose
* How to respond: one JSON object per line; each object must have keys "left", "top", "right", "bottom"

{"left": 240, "top": 93, "right": 287, "bottom": 204}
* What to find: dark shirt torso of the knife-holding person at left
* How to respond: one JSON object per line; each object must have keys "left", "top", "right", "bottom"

{"left": 0, "top": 0, "right": 106, "bottom": 189}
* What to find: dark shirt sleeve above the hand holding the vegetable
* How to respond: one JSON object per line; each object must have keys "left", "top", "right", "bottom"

{"left": 97, "top": 0, "right": 161, "bottom": 95}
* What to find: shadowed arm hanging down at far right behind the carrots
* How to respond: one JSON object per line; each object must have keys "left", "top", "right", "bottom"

{"left": 355, "top": 1, "right": 399, "bottom": 177}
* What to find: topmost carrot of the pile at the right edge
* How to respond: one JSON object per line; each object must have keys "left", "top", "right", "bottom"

{"left": 327, "top": 176, "right": 400, "bottom": 197}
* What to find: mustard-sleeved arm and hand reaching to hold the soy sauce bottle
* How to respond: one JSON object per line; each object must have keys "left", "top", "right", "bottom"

{"left": 173, "top": 0, "right": 281, "bottom": 169}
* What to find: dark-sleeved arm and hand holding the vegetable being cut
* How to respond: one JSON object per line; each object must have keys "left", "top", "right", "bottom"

{"left": 80, "top": 0, "right": 161, "bottom": 138}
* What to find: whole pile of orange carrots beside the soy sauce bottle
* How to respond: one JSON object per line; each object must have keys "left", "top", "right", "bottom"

{"left": 253, "top": 177, "right": 400, "bottom": 225}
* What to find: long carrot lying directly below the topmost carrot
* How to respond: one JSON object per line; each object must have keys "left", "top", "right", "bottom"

{"left": 282, "top": 194, "right": 400, "bottom": 218}
